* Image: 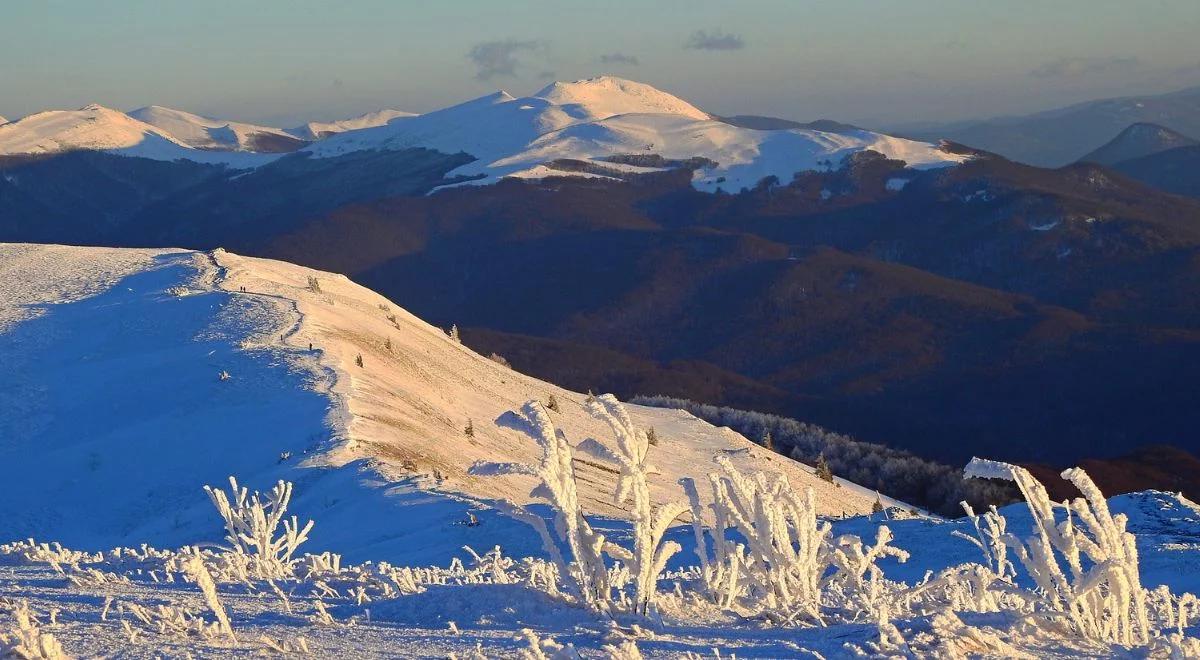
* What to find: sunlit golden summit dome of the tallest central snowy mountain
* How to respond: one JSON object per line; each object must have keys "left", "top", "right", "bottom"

{"left": 534, "top": 76, "right": 709, "bottom": 120}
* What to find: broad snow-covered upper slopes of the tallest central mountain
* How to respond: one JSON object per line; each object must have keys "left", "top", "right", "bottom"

{"left": 306, "top": 77, "right": 965, "bottom": 191}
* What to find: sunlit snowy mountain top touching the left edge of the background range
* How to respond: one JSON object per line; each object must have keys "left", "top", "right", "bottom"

{"left": 0, "top": 104, "right": 274, "bottom": 167}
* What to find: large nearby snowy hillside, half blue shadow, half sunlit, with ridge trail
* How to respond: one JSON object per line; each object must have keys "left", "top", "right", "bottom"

{"left": 0, "top": 245, "right": 875, "bottom": 559}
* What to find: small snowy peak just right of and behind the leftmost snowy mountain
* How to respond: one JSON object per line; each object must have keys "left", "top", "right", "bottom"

{"left": 128, "top": 106, "right": 301, "bottom": 151}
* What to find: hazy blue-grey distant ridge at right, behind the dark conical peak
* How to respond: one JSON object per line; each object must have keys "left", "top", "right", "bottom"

{"left": 895, "top": 88, "right": 1200, "bottom": 167}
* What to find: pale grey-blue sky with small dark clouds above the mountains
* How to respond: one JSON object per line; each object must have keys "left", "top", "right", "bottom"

{"left": 0, "top": 0, "right": 1200, "bottom": 127}
